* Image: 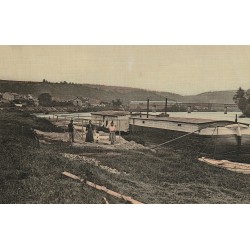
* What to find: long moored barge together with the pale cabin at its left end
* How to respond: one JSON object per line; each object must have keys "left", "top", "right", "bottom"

{"left": 91, "top": 111, "right": 250, "bottom": 146}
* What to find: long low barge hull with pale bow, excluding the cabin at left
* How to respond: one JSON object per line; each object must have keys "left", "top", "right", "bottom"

{"left": 129, "top": 117, "right": 250, "bottom": 146}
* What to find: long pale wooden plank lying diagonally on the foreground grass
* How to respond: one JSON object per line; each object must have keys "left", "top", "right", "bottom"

{"left": 62, "top": 171, "right": 143, "bottom": 204}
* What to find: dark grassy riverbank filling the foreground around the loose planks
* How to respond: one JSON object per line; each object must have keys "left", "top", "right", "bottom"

{"left": 0, "top": 111, "right": 250, "bottom": 203}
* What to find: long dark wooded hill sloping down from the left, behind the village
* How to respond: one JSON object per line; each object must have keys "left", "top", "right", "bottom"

{"left": 0, "top": 80, "right": 181, "bottom": 103}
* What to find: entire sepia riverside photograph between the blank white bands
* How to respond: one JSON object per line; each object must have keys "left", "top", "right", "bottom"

{"left": 0, "top": 45, "right": 250, "bottom": 204}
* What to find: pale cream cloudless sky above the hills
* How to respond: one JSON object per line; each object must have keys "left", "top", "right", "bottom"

{"left": 0, "top": 45, "right": 250, "bottom": 95}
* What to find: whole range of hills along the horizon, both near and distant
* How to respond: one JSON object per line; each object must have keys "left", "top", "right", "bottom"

{"left": 0, "top": 80, "right": 236, "bottom": 103}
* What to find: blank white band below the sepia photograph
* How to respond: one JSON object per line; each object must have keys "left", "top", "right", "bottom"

{"left": 0, "top": 205, "right": 250, "bottom": 250}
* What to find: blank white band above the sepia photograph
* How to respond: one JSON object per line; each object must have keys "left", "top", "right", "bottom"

{"left": 0, "top": 0, "right": 250, "bottom": 45}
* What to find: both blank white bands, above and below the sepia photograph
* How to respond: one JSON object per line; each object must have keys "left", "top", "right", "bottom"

{"left": 0, "top": 0, "right": 250, "bottom": 250}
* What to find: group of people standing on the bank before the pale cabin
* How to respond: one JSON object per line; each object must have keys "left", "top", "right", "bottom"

{"left": 68, "top": 119, "right": 116, "bottom": 145}
